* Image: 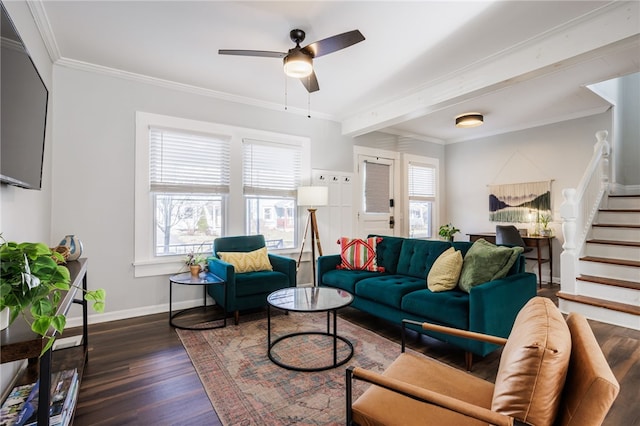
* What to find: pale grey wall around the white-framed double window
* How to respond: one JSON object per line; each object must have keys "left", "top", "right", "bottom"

{"left": 52, "top": 65, "right": 352, "bottom": 321}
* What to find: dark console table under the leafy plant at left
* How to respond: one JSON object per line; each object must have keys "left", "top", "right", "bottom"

{"left": 0, "top": 258, "right": 89, "bottom": 426}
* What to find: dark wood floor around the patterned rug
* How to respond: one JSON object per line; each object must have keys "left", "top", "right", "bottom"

{"left": 65, "top": 287, "right": 640, "bottom": 426}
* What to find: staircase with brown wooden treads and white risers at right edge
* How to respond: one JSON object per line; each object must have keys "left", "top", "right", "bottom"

{"left": 558, "top": 195, "right": 640, "bottom": 330}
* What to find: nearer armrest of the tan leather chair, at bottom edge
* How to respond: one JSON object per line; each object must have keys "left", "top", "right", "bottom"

{"left": 346, "top": 367, "right": 524, "bottom": 426}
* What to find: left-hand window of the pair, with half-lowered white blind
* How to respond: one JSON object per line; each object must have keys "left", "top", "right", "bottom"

{"left": 149, "top": 128, "right": 230, "bottom": 256}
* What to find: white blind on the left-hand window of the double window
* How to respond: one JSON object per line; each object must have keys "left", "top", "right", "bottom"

{"left": 149, "top": 128, "right": 231, "bottom": 194}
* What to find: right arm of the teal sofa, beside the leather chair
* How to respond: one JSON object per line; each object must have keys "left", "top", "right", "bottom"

{"left": 469, "top": 272, "right": 537, "bottom": 337}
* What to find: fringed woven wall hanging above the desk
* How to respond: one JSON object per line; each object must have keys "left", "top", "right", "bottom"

{"left": 489, "top": 180, "right": 552, "bottom": 223}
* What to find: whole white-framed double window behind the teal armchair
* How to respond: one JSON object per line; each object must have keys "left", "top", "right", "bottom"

{"left": 134, "top": 112, "right": 311, "bottom": 277}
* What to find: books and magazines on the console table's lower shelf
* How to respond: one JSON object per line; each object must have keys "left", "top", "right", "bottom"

{"left": 0, "top": 368, "right": 78, "bottom": 426}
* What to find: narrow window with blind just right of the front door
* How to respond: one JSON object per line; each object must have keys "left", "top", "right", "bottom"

{"left": 406, "top": 160, "right": 437, "bottom": 238}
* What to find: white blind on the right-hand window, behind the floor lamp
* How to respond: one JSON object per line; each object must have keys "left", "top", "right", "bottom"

{"left": 242, "top": 139, "right": 302, "bottom": 197}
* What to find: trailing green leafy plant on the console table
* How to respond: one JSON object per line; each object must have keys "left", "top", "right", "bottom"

{"left": 0, "top": 236, "right": 105, "bottom": 353}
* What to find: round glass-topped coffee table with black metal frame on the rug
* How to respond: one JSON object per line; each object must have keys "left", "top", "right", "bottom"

{"left": 267, "top": 287, "right": 353, "bottom": 371}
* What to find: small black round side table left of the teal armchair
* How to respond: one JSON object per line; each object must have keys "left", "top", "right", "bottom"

{"left": 169, "top": 272, "right": 227, "bottom": 330}
